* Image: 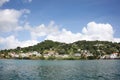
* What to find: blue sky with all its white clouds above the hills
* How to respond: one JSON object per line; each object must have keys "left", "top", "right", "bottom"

{"left": 0, "top": 0, "right": 120, "bottom": 50}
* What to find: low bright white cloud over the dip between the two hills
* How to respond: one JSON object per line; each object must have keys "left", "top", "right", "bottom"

{"left": 46, "top": 29, "right": 82, "bottom": 43}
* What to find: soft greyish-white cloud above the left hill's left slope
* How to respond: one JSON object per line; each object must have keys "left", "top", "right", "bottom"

{"left": 27, "top": 21, "right": 59, "bottom": 39}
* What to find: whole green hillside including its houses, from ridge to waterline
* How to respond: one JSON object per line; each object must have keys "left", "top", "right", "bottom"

{"left": 0, "top": 40, "right": 120, "bottom": 59}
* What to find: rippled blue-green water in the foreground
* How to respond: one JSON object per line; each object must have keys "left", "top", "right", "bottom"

{"left": 0, "top": 60, "right": 120, "bottom": 80}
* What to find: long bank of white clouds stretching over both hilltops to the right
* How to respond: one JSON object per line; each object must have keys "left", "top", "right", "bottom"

{"left": 27, "top": 21, "right": 118, "bottom": 43}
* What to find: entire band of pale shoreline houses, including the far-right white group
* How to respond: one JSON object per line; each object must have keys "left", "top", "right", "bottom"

{"left": 8, "top": 50, "right": 120, "bottom": 59}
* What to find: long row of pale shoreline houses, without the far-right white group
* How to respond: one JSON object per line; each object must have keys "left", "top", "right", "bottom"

{"left": 8, "top": 51, "right": 93, "bottom": 58}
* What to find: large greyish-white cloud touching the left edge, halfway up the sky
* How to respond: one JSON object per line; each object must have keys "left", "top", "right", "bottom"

{"left": 0, "top": 9, "right": 29, "bottom": 32}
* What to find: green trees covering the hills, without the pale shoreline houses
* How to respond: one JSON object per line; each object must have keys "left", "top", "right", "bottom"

{"left": 0, "top": 40, "right": 120, "bottom": 59}
